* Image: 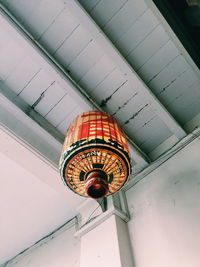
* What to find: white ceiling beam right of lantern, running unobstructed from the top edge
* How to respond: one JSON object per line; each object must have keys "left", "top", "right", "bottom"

{"left": 64, "top": 0, "right": 186, "bottom": 140}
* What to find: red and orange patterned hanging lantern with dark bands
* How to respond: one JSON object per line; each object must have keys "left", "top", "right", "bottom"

{"left": 60, "top": 111, "right": 131, "bottom": 199}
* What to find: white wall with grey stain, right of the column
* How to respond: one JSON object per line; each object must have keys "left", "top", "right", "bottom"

{"left": 127, "top": 141, "right": 200, "bottom": 267}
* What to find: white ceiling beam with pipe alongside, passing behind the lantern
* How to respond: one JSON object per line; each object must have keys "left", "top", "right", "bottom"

{"left": 0, "top": 4, "right": 149, "bottom": 172}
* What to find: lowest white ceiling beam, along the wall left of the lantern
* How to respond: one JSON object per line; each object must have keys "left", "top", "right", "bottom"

{"left": 0, "top": 92, "right": 61, "bottom": 168}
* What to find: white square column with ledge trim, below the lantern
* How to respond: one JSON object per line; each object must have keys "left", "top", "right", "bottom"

{"left": 76, "top": 194, "right": 134, "bottom": 267}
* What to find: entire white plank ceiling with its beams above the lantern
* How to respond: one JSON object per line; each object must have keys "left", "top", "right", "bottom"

{"left": 0, "top": 0, "right": 200, "bottom": 264}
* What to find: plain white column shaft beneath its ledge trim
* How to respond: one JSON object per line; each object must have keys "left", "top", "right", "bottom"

{"left": 80, "top": 215, "right": 133, "bottom": 267}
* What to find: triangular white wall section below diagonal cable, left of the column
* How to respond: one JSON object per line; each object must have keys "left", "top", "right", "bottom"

{"left": 2, "top": 218, "right": 80, "bottom": 267}
